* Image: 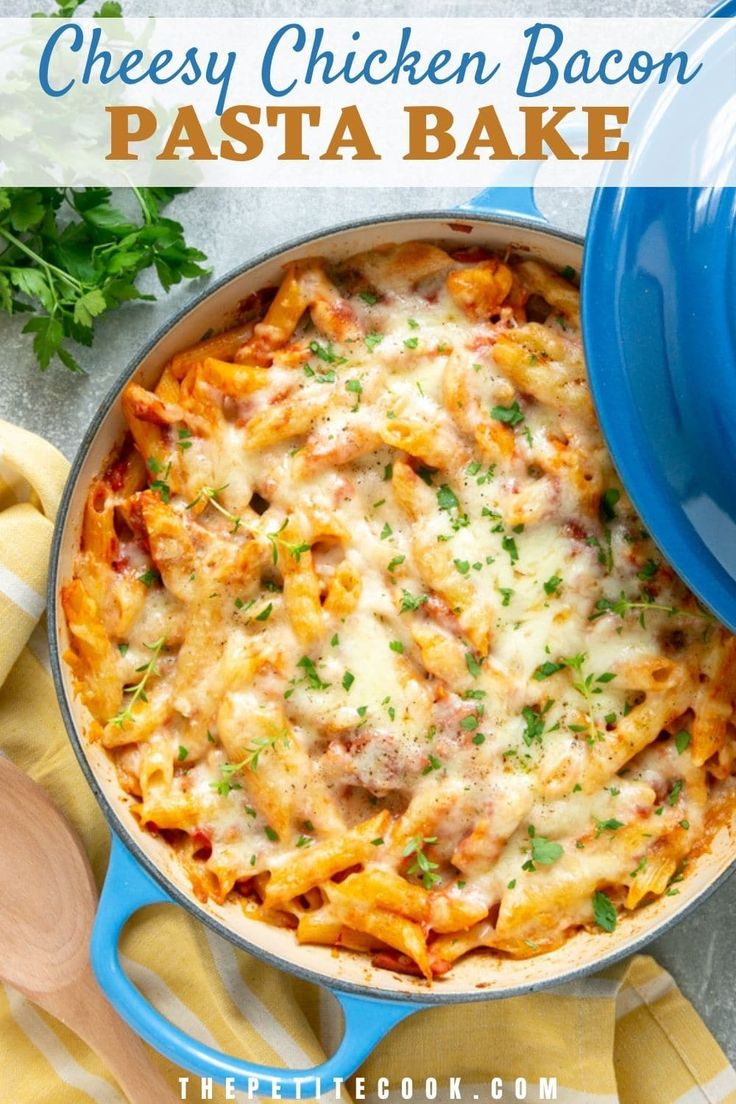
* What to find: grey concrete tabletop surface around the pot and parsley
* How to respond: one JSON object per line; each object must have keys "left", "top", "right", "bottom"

{"left": 0, "top": 0, "right": 736, "bottom": 1077}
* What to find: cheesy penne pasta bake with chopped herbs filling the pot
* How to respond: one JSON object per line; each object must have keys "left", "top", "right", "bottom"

{"left": 63, "top": 242, "right": 736, "bottom": 979}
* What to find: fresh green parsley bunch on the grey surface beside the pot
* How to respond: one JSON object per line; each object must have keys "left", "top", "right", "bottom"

{"left": 0, "top": 188, "right": 210, "bottom": 372}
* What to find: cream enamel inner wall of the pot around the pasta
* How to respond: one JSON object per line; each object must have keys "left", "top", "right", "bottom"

{"left": 57, "top": 214, "right": 736, "bottom": 1000}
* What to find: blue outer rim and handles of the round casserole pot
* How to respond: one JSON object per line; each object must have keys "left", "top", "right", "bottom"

{"left": 47, "top": 188, "right": 736, "bottom": 1098}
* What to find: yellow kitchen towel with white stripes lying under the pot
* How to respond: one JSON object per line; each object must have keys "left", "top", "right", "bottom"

{"left": 0, "top": 422, "right": 736, "bottom": 1104}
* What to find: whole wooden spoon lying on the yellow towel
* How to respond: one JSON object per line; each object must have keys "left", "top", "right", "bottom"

{"left": 0, "top": 753, "right": 178, "bottom": 1104}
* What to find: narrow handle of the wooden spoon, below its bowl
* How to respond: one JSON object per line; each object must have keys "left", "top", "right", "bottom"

{"left": 37, "top": 968, "right": 180, "bottom": 1104}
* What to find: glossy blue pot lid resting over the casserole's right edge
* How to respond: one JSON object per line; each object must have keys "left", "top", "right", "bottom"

{"left": 582, "top": 0, "right": 736, "bottom": 631}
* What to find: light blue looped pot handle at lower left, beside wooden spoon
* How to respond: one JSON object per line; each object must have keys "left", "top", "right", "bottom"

{"left": 90, "top": 834, "right": 427, "bottom": 1100}
